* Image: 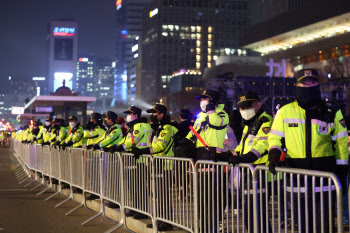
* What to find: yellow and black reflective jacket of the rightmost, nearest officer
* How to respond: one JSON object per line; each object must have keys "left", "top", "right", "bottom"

{"left": 269, "top": 101, "right": 349, "bottom": 172}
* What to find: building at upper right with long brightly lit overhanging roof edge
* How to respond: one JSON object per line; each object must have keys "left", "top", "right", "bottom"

{"left": 243, "top": 0, "right": 350, "bottom": 115}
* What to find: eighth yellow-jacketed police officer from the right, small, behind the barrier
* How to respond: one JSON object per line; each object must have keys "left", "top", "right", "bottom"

{"left": 61, "top": 116, "right": 84, "bottom": 150}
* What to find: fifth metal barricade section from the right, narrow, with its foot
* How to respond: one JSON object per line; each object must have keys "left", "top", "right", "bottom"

{"left": 101, "top": 152, "right": 124, "bottom": 232}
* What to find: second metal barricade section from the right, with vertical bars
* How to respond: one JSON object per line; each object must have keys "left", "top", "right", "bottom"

{"left": 195, "top": 160, "right": 254, "bottom": 233}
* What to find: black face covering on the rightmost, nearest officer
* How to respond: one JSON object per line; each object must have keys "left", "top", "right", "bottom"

{"left": 295, "top": 85, "right": 322, "bottom": 109}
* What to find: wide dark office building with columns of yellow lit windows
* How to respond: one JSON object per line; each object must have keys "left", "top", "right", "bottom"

{"left": 137, "top": 0, "right": 249, "bottom": 104}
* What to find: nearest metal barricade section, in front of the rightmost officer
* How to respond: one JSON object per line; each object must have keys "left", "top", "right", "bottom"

{"left": 253, "top": 166, "right": 344, "bottom": 233}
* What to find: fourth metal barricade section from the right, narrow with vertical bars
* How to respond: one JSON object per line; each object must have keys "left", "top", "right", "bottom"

{"left": 121, "top": 153, "right": 154, "bottom": 230}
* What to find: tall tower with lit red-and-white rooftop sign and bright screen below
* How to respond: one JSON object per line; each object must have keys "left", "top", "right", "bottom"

{"left": 47, "top": 21, "right": 78, "bottom": 92}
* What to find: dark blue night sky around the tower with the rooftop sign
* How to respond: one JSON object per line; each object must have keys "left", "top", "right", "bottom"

{"left": 0, "top": 0, "right": 116, "bottom": 82}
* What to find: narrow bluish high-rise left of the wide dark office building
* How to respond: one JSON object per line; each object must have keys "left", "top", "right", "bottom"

{"left": 113, "top": 0, "right": 151, "bottom": 105}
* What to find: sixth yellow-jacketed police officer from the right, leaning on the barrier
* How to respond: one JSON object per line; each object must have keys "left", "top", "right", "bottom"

{"left": 92, "top": 111, "right": 123, "bottom": 151}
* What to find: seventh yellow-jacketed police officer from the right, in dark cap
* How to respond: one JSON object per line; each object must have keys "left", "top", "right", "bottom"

{"left": 83, "top": 112, "right": 106, "bottom": 149}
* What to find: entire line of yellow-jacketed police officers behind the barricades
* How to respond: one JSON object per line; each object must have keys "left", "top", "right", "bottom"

{"left": 16, "top": 69, "right": 349, "bottom": 232}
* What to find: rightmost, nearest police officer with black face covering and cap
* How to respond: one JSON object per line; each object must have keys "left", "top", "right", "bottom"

{"left": 269, "top": 69, "right": 349, "bottom": 232}
